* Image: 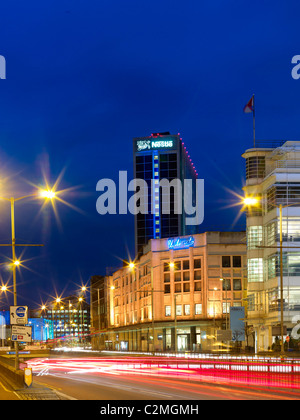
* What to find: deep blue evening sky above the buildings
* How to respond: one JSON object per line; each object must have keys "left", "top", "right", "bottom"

{"left": 0, "top": 0, "right": 300, "bottom": 306}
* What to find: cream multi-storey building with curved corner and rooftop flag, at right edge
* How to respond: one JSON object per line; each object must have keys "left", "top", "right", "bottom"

{"left": 243, "top": 141, "right": 300, "bottom": 351}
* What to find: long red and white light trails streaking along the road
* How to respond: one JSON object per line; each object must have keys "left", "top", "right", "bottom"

{"left": 28, "top": 358, "right": 300, "bottom": 390}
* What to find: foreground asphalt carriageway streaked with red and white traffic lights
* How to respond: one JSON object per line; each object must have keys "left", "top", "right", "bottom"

{"left": 25, "top": 359, "right": 300, "bottom": 401}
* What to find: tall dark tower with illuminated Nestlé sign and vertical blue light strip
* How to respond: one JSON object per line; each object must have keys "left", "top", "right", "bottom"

{"left": 133, "top": 132, "right": 198, "bottom": 254}
